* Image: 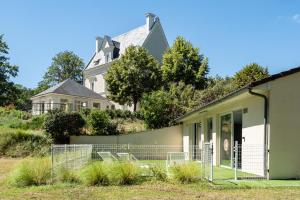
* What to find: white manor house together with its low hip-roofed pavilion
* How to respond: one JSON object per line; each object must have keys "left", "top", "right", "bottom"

{"left": 31, "top": 13, "right": 169, "bottom": 114}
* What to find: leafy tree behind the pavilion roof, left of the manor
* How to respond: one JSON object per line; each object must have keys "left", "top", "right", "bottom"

{"left": 39, "top": 51, "right": 84, "bottom": 90}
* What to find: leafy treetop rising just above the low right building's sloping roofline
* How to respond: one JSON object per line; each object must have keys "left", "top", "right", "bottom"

{"left": 234, "top": 63, "right": 269, "bottom": 88}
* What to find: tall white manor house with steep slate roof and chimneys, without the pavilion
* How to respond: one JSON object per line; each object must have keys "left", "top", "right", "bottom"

{"left": 83, "top": 13, "right": 169, "bottom": 110}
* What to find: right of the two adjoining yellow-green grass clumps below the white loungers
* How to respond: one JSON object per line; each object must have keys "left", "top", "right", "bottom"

{"left": 111, "top": 162, "right": 141, "bottom": 185}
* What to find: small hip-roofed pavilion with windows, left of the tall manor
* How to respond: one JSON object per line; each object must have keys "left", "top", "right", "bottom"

{"left": 31, "top": 79, "right": 114, "bottom": 115}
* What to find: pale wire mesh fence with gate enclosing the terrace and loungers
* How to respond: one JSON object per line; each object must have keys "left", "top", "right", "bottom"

{"left": 51, "top": 143, "right": 266, "bottom": 181}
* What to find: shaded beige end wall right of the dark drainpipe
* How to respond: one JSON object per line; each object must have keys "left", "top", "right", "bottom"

{"left": 269, "top": 72, "right": 300, "bottom": 179}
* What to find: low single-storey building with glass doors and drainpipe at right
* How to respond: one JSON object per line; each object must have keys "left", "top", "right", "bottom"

{"left": 177, "top": 67, "right": 300, "bottom": 179}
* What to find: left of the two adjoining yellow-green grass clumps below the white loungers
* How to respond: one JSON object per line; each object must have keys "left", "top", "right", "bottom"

{"left": 80, "top": 161, "right": 110, "bottom": 186}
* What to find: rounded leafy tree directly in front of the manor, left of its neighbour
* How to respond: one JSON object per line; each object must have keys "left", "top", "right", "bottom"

{"left": 105, "top": 46, "right": 161, "bottom": 111}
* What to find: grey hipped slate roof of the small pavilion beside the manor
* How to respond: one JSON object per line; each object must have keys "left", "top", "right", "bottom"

{"left": 32, "top": 79, "right": 107, "bottom": 100}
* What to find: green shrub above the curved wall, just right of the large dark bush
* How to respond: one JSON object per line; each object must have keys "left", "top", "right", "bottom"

{"left": 87, "top": 110, "right": 118, "bottom": 135}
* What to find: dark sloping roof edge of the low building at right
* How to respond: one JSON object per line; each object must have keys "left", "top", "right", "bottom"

{"left": 176, "top": 66, "right": 300, "bottom": 122}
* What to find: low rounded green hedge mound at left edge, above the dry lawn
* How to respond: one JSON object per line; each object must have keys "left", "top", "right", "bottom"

{"left": 0, "top": 128, "right": 51, "bottom": 157}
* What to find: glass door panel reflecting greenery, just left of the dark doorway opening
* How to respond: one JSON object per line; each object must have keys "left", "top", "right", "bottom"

{"left": 220, "top": 113, "right": 232, "bottom": 167}
